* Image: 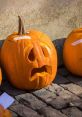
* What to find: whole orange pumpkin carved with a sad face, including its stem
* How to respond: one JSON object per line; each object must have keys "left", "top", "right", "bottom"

{"left": 1, "top": 17, "right": 57, "bottom": 89}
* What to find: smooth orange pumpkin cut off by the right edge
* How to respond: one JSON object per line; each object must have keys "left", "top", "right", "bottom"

{"left": 63, "top": 28, "right": 82, "bottom": 76}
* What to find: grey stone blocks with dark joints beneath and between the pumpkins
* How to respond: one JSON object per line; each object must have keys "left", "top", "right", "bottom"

{"left": 0, "top": 39, "right": 82, "bottom": 117}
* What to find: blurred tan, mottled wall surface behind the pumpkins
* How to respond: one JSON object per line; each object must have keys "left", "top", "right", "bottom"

{"left": 0, "top": 0, "right": 82, "bottom": 40}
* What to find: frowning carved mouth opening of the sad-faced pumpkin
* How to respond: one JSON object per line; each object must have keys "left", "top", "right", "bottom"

{"left": 31, "top": 65, "right": 52, "bottom": 77}
